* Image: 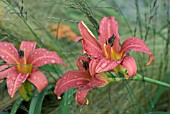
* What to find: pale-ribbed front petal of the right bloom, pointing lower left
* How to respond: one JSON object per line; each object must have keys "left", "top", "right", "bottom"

{"left": 96, "top": 58, "right": 122, "bottom": 73}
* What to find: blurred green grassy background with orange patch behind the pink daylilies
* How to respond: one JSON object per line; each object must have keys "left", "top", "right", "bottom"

{"left": 0, "top": 0, "right": 170, "bottom": 114}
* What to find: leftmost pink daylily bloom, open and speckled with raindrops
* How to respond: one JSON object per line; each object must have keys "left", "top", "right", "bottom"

{"left": 0, "top": 41, "right": 63, "bottom": 97}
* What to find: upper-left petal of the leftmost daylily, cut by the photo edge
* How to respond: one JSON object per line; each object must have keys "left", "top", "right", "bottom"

{"left": 0, "top": 42, "right": 19, "bottom": 64}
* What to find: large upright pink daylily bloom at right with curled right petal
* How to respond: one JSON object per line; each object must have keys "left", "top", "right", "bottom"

{"left": 75, "top": 17, "right": 154, "bottom": 78}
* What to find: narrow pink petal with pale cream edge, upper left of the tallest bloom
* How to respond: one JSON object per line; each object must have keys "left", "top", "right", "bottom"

{"left": 78, "top": 21, "right": 100, "bottom": 48}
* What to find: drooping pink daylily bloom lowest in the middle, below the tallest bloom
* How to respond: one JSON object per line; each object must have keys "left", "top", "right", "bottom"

{"left": 54, "top": 56, "right": 108, "bottom": 105}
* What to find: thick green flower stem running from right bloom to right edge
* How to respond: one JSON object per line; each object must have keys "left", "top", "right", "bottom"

{"left": 109, "top": 74, "right": 170, "bottom": 88}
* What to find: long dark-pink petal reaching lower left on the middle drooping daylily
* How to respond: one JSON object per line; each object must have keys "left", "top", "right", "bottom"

{"left": 54, "top": 71, "right": 89, "bottom": 99}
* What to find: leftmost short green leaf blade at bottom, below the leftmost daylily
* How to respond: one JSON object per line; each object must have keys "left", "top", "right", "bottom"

{"left": 10, "top": 97, "right": 23, "bottom": 114}
